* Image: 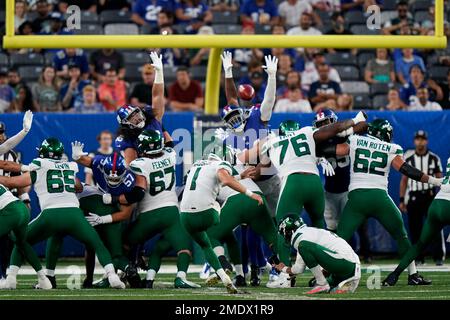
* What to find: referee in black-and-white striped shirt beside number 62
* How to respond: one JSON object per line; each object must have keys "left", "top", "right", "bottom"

{"left": 400, "top": 130, "right": 445, "bottom": 266}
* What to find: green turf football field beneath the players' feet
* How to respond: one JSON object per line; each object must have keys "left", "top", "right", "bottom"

{"left": 0, "top": 261, "right": 450, "bottom": 300}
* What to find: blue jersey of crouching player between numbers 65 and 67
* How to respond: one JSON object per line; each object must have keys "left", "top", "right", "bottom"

{"left": 92, "top": 155, "right": 136, "bottom": 196}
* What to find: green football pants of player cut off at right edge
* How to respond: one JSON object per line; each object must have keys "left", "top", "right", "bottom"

{"left": 395, "top": 199, "right": 450, "bottom": 274}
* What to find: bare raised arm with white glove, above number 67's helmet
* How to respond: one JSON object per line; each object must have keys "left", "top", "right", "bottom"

{"left": 150, "top": 51, "right": 166, "bottom": 122}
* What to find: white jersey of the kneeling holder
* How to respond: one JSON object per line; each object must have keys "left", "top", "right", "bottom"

{"left": 291, "top": 226, "right": 360, "bottom": 263}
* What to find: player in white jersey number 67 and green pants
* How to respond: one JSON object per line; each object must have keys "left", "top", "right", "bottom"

{"left": 103, "top": 130, "right": 200, "bottom": 289}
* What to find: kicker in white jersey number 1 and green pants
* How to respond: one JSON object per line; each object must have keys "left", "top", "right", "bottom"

{"left": 181, "top": 153, "right": 264, "bottom": 293}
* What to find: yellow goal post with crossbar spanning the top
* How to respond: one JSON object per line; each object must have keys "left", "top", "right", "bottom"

{"left": 3, "top": 0, "right": 447, "bottom": 114}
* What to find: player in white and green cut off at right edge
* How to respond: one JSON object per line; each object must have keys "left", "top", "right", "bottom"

{"left": 383, "top": 158, "right": 450, "bottom": 286}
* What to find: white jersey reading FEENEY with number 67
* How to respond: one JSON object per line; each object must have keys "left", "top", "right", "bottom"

{"left": 130, "top": 148, "right": 178, "bottom": 212}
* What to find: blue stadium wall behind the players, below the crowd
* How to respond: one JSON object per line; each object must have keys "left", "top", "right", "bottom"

{"left": 0, "top": 111, "right": 450, "bottom": 256}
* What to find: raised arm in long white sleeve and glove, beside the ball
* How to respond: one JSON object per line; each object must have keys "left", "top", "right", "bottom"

{"left": 261, "top": 55, "right": 278, "bottom": 121}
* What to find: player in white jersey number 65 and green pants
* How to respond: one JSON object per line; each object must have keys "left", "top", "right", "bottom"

{"left": 0, "top": 138, "right": 125, "bottom": 289}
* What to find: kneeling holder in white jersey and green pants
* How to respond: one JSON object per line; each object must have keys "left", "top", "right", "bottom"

{"left": 276, "top": 215, "right": 361, "bottom": 294}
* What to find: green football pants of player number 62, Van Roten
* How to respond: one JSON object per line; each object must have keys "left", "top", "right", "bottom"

{"left": 336, "top": 189, "right": 411, "bottom": 257}
